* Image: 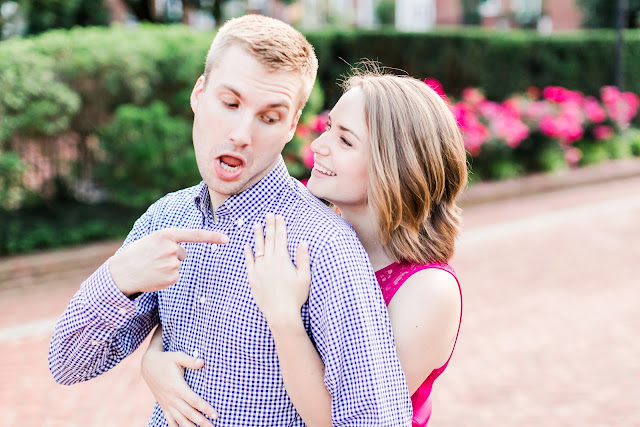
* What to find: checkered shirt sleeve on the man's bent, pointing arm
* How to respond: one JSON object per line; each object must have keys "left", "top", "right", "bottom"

{"left": 49, "top": 209, "right": 159, "bottom": 385}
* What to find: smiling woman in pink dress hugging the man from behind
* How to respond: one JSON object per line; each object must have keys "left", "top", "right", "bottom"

{"left": 142, "top": 72, "right": 467, "bottom": 427}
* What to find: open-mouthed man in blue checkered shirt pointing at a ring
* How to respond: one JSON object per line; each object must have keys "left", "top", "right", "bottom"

{"left": 49, "top": 15, "right": 411, "bottom": 426}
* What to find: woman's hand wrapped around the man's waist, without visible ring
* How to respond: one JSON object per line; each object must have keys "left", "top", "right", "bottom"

{"left": 141, "top": 327, "right": 218, "bottom": 427}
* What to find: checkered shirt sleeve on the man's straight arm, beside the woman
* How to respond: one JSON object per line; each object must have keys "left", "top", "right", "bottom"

{"left": 309, "top": 234, "right": 412, "bottom": 427}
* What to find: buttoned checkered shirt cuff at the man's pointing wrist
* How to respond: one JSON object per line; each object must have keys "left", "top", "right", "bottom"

{"left": 82, "top": 260, "right": 138, "bottom": 328}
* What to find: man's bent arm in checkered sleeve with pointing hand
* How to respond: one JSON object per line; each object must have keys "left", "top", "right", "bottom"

{"left": 49, "top": 205, "right": 229, "bottom": 384}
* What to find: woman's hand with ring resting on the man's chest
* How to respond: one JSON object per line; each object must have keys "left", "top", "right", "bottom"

{"left": 244, "top": 213, "right": 311, "bottom": 330}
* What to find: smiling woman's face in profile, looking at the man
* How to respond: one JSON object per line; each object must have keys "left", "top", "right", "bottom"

{"left": 307, "top": 87, "right": 371, "bottom": 210}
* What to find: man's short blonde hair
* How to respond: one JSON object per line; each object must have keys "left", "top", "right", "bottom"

{"left": 204, "top": 15, "right": 318, "bottom": 109}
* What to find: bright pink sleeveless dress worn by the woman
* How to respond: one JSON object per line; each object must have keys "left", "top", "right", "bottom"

{"left": 376, "top": 262, "right": 462, "bottom": 427}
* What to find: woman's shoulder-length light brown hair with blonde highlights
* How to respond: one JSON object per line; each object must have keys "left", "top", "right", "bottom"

{"left": 343, "top": 69, "right": 467, "bottom": 263}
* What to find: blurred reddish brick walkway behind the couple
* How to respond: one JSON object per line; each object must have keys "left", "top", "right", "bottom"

{"left": 0, "top": 161, "right": 640, "bottom": 427}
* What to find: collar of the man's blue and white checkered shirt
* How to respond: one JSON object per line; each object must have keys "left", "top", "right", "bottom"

{"left": 193, "top": 156, "right": 291, "bottom": 219}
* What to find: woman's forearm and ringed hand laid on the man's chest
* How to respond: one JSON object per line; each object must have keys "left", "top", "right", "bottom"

{"left": 245, "top": 214, "right": 331, "bottom": 426}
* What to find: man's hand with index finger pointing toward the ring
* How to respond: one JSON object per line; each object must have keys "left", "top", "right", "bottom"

{"left": 109, "top": 228, "right": 229, "bottom": 296}
